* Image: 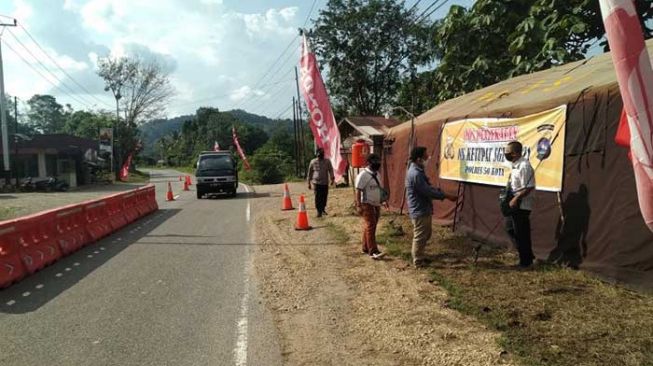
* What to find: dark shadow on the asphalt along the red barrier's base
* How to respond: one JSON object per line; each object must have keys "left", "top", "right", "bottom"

{"left": 0, "top": 209, "right": 181, "bottom": 314}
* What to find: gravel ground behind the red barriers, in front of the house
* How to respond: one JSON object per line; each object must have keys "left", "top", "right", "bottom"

{"left": 0, "top": 183, "right": 142, "bottom": 220}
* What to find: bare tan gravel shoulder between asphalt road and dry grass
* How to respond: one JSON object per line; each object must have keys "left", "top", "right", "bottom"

{"left": 252, "top": 184, "right": 514, "bottom": 365}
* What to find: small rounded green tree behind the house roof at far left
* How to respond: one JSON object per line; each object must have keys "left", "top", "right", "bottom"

{"left": 27, "top": 94, "right": 64, "bottom": 134}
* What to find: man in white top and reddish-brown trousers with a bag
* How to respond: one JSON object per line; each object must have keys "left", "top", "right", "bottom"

{"left": 355, "top": 154, "right": 388, "bottom": 260}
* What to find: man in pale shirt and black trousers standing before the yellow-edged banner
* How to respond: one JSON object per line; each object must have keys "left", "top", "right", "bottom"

{"left": 505, "top": 141, "right": 535, "bottom": 268}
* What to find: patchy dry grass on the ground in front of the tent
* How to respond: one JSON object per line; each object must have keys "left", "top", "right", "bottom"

{"left": 378, "top": 214, "right": 653, "bottom": 366}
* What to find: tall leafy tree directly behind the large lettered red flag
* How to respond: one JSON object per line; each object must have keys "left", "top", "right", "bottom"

{"left": 309, "top": 0, "right": 433, "bottom": 114}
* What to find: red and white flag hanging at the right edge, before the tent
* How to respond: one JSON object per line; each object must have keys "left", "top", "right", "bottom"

{"left": 600, "top": 0, "right": 653, "bottom": 231}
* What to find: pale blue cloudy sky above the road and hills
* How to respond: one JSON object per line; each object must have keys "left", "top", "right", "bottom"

{"left": 0, "top": 0, "right": 473, "bottom": 118}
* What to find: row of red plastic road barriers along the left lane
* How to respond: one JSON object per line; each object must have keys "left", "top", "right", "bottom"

{"left": 0, "top": 184, "right": 159, "bottom": 288}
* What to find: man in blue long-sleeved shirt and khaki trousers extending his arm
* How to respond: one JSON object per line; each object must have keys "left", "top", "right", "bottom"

{"left": 406, "top": 146, "right": 456, "bottom": 268}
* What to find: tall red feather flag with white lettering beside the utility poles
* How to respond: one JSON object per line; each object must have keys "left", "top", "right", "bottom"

{"left": 299, "top": 35, "right": 347, "bottom": 181}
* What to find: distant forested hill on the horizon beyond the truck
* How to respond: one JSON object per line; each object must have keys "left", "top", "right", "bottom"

{"left": 140, "top": 109, "right": 293, "bottom": 156}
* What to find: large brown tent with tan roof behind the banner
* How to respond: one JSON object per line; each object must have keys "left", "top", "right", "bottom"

{"left": 384, "top": 41, "right": 653, "bottom": 286}
